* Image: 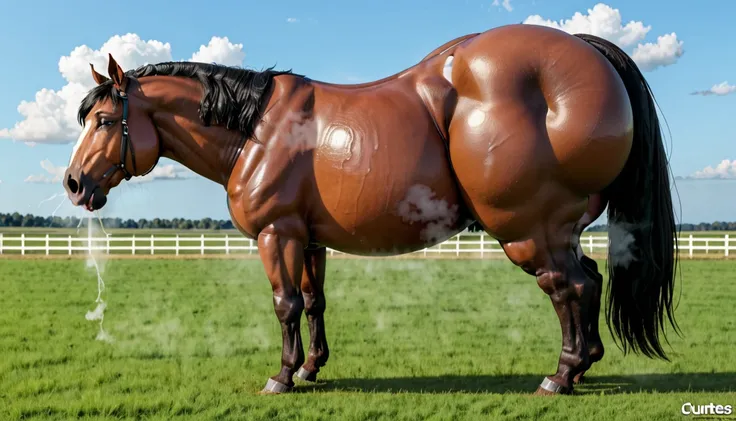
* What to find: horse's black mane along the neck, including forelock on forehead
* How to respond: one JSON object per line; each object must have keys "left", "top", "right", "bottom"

{"left": 77, "top": 62, "right": 291, "bottom": 139}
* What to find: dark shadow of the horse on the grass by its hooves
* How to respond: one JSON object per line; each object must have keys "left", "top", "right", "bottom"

{"left": 295, "top": 373, "right": 736, "bottom": 395}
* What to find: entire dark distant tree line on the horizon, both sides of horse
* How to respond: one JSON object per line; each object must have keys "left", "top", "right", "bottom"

{"left": 0, "top": 212, "right": 736, "bottom": 232}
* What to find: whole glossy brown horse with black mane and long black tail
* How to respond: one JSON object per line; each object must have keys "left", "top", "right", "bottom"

{"left": 63, "top": 25, "right": 677, "bottom": 394}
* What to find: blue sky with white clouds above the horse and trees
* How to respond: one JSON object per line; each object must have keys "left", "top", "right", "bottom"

{"left": 0, "top": 0, "right": 736, "bottom": 222}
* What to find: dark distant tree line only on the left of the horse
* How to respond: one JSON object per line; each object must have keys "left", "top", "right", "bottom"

{"left": 0, "top": 212, "right": 233, "bottom": 230}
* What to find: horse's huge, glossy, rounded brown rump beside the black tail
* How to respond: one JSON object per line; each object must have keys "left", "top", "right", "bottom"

{"left": 450, "top": 25, "right": 633, "bottom": 240}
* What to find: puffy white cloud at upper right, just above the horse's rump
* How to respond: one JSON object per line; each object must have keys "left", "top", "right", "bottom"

{"left": 524, "top": 3, "right": 685, "bottom": 71}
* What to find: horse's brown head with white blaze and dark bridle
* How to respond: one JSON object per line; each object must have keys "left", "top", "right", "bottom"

{"left": 63, "top": 55, "right": 160, "bottom": 211}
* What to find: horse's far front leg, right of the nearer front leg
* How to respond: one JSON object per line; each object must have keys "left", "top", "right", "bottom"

{"left": 296, "top": 247, "right": 330, "bottom": 382}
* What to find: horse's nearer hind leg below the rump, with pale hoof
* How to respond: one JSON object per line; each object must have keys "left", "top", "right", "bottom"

{"left": 503, "top": 225, "right": 594, "bottom": 394}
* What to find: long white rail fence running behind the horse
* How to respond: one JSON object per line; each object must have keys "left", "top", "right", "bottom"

{"left": 0, "top": 233, "right": 736, "bottom": 258}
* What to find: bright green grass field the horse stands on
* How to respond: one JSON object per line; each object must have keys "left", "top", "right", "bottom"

{"left": 0, "top": 259, "right": 736, "bottom": 421}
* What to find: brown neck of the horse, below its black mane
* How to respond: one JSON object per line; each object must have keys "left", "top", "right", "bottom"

{"left": 141, "top": 77, "right": 244, "bottom": 185}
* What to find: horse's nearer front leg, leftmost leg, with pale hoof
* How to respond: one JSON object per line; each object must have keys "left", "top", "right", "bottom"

{"left": 258, "top": 221, "right": 306, "bottom": 393}
